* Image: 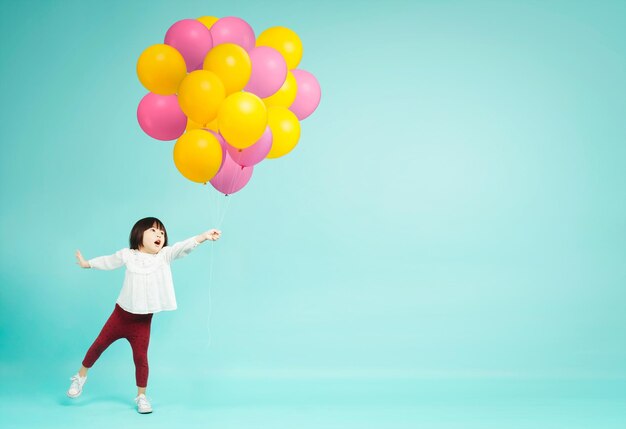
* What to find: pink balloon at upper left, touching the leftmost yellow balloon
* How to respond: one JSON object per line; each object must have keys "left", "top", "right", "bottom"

{"left": 165, "top": 19, "right": 213, "bottom": 72}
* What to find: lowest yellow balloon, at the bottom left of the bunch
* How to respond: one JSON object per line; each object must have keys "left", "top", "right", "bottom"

{"left": 174, "top": 130, "right": 222, "bottom": 183}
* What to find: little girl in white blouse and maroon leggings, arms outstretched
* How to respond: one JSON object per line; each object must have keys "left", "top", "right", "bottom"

{"left": 67, "top": 217, "right": 221, "bottom": 414}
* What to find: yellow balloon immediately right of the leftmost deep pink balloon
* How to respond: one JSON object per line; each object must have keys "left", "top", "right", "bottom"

{"left": 178, "top": 70, "right": 226, "bottom": 126}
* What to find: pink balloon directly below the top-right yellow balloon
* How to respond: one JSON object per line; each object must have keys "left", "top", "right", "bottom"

{"left": 244, "top": 46, "right": 287, "bottom": 98}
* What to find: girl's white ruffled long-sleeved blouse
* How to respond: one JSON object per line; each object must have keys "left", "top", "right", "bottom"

{"left": 88, "top": 237, "right": 199, "bottom": 314}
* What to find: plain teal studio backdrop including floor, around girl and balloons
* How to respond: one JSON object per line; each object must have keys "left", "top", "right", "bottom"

{"left": 0, "top": 0, "right": 626, "bottom": 428}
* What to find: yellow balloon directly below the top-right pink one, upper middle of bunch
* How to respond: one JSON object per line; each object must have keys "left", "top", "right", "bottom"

{"left": 203, "top": 43, "right": 252, "bottom": 95}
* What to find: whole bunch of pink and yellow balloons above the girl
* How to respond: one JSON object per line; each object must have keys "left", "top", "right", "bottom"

{"left": 137, "top": 16, "right": 321, "bottom": 195}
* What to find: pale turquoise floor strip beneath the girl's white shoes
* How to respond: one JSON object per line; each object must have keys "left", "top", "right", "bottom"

{"left": 0, "top": 369, "right": 626, "bottom": 429}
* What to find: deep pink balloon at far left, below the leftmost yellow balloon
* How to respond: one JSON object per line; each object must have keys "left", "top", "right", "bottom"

{"left": 137, "top": 92, "right": 187, "bottom": 140}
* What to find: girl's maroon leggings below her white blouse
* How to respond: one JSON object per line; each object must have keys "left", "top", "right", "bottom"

{"left": 83, "top": 304, "right": 152, "bottom": 387}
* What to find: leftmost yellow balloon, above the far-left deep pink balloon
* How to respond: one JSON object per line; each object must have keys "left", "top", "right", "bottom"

{"left": 137, "top": 44, "right": 187, "bottom": 95}
